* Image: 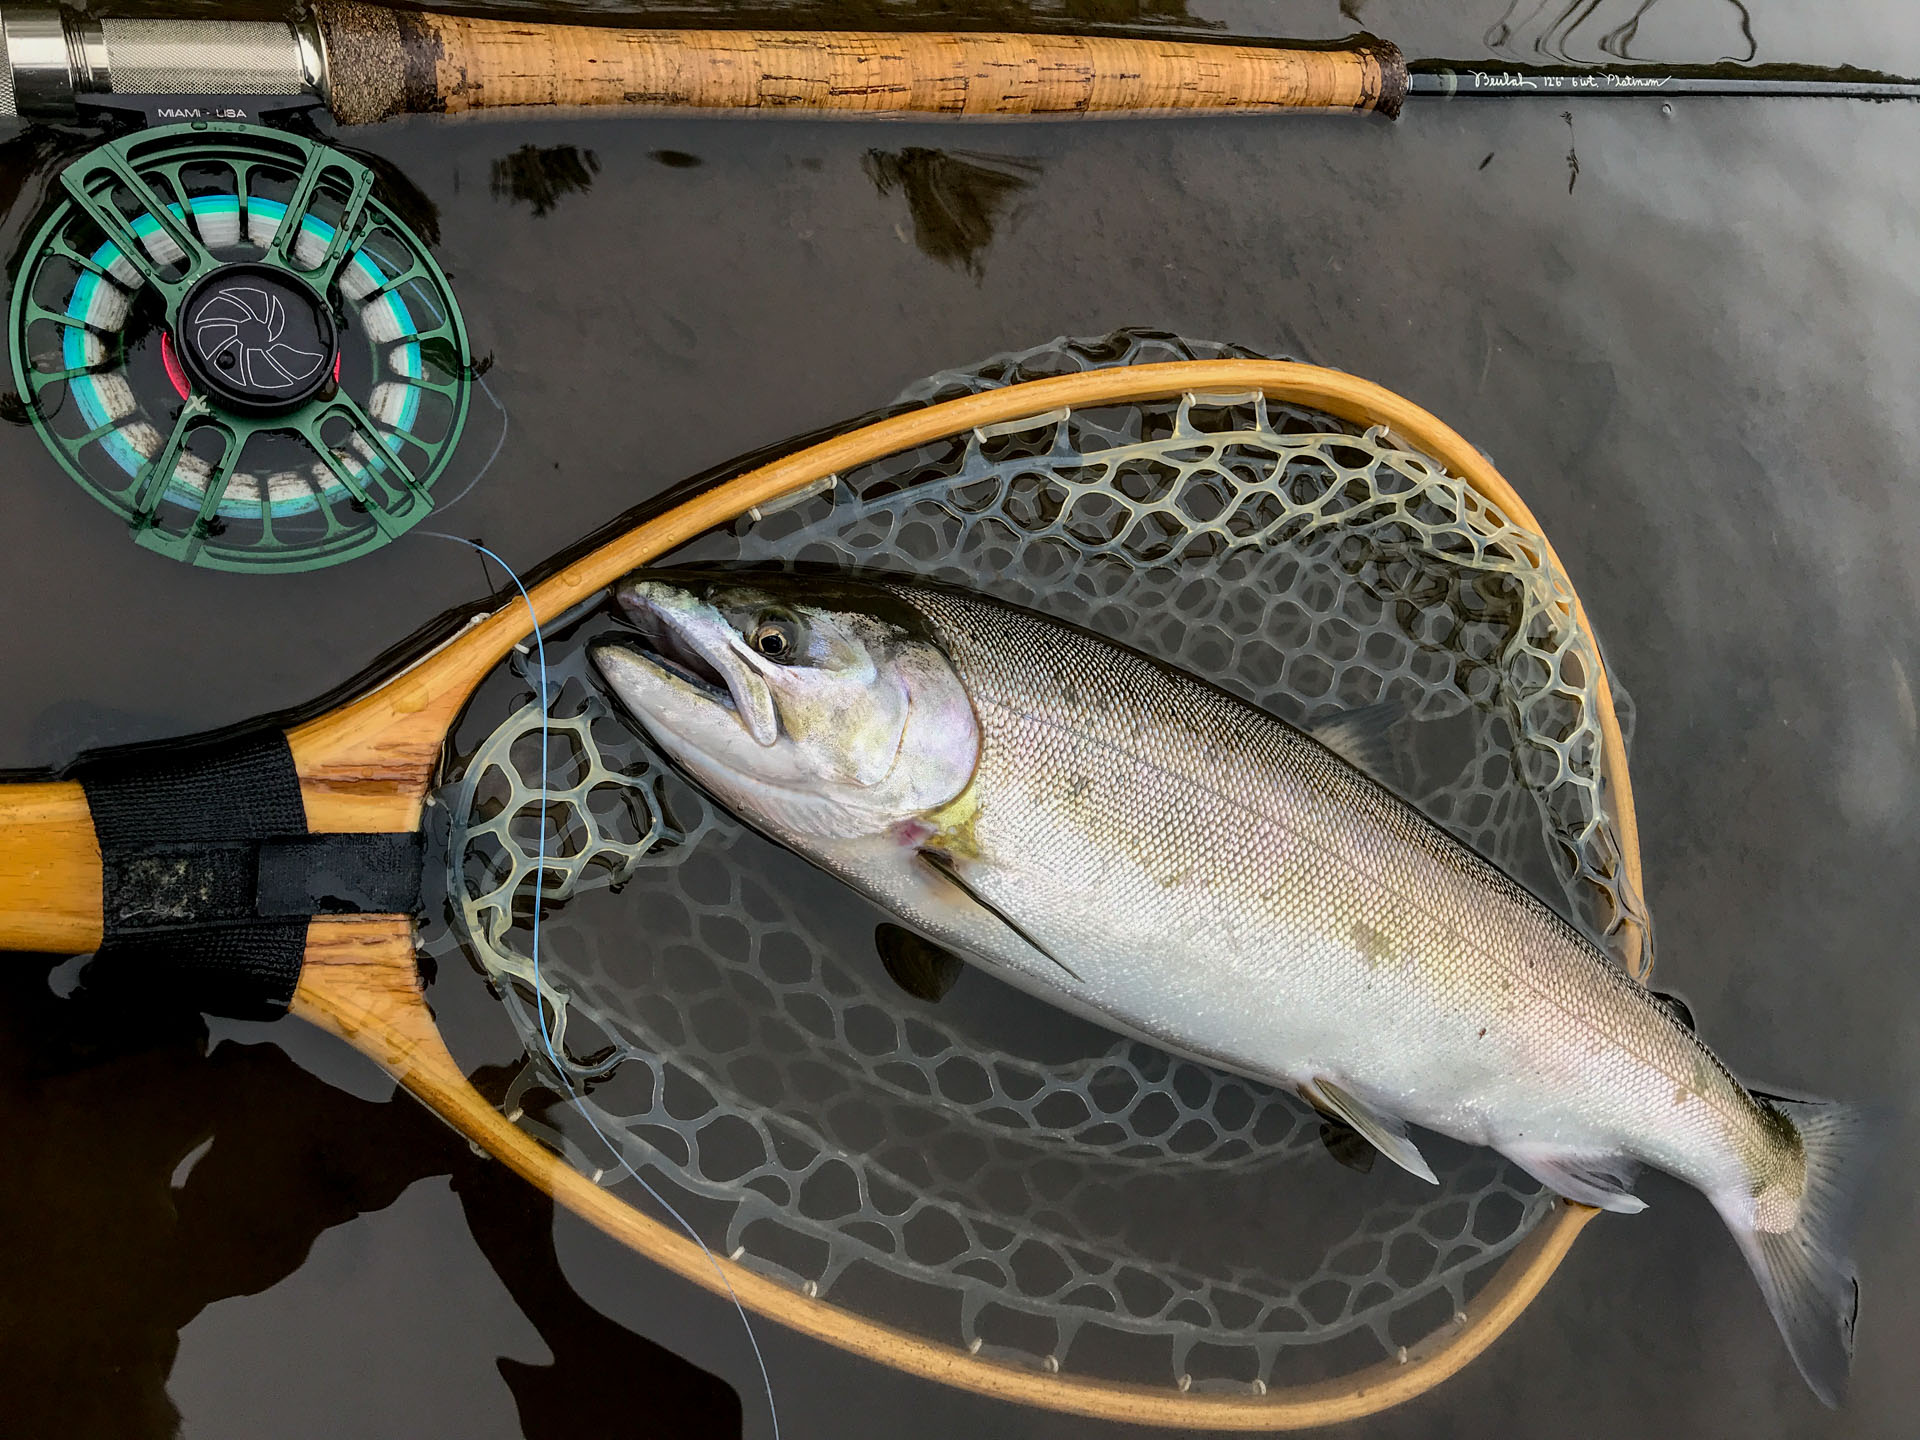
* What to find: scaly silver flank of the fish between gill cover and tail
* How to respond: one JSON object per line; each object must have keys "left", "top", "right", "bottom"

{"left": 897, "top": 588, "right": 1764, "bottom": 1185}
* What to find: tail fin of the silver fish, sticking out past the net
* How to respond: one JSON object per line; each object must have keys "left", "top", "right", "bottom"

{"left": 1718, "top": 1096, "right": 1878, "bottom": 1407}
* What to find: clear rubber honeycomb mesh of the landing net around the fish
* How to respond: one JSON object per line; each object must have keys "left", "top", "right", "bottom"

{"left": 424, "top": 332, "right": 1645, "bottom": 1392}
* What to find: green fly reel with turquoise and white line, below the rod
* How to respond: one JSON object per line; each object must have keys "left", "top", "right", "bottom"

{"left": 12, "top": 121, "right": 472, "bottom": 572}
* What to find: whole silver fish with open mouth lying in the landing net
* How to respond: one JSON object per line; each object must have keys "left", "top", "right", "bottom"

{"left": 593, "top": 572, "right": 1866, "bottom": 1405}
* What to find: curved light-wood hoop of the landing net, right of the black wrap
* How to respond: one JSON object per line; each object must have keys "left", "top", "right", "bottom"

{"left": 288, "top": 359, "right": 1640, "bottom": 1430}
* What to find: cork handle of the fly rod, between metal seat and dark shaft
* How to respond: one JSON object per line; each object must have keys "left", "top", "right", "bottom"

{"left": 317, "top": 0, "right": 1407, "bottom": 125}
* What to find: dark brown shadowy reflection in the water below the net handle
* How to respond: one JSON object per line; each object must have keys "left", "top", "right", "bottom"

{"left": 0, "top": 964, "right": 741, "bottom": 1440}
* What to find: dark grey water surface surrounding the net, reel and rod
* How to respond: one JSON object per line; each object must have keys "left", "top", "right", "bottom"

{"left": 0, "top": 0, "right": 1920, "bottom": 1440}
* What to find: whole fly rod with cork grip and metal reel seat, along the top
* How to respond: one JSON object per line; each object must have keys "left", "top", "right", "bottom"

{"left": 0, "top": 0, "right": 1920, "bottom": 125}
